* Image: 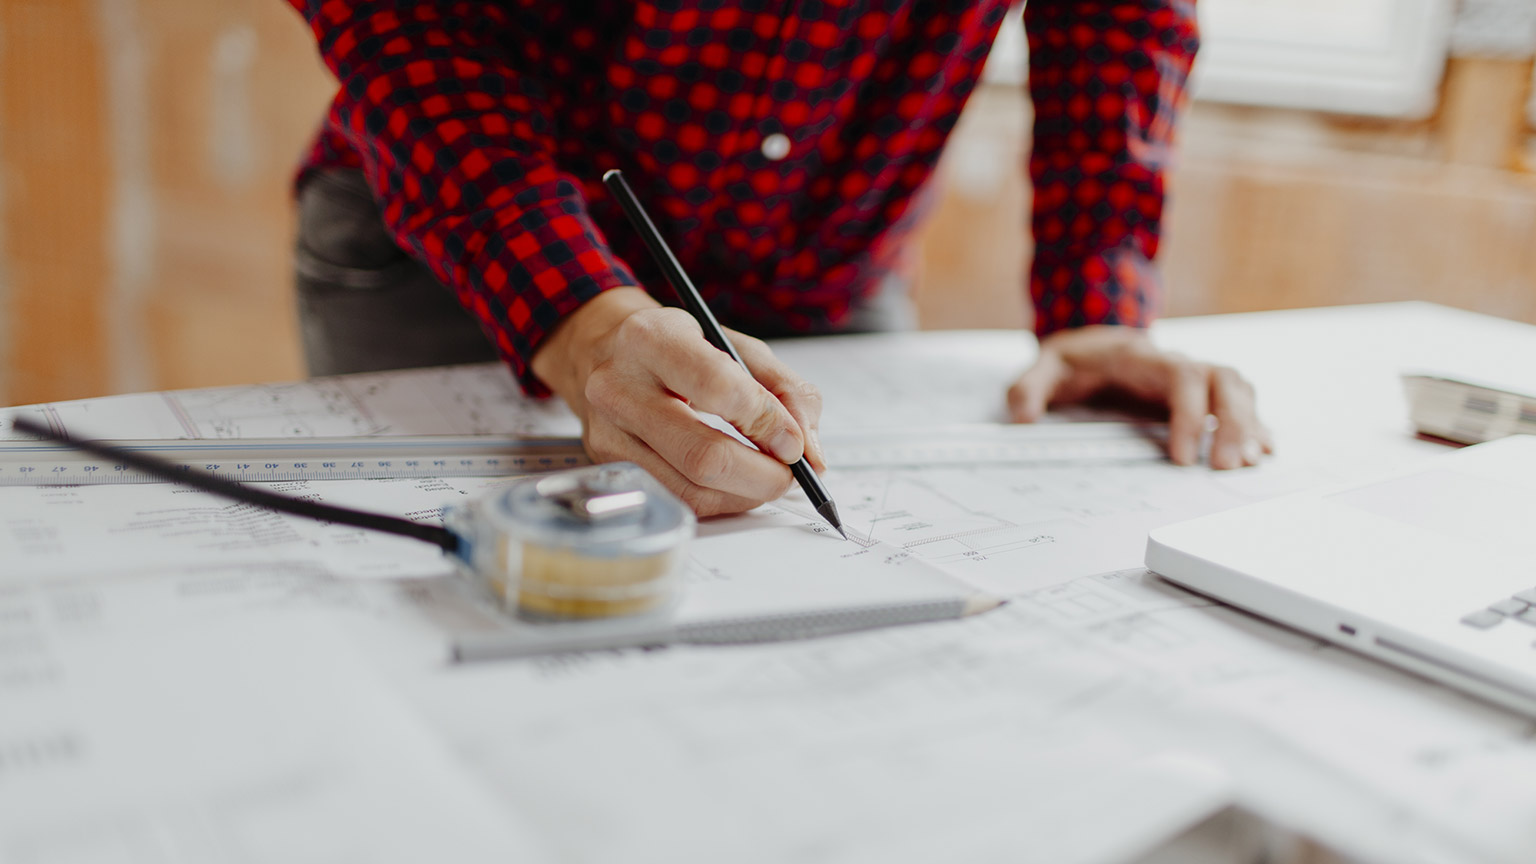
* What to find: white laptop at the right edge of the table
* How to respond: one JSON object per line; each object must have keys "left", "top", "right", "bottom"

{"left": 1146, "top": 435, "right": 1536, "bottom": 716}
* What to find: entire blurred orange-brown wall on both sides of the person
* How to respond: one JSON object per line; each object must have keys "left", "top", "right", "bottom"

{"left": 0, "top": 0, "right": 1536, "bottom": 404}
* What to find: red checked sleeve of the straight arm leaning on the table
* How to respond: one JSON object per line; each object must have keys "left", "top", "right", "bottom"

{"left": 1025, "top": 0, "right": 1200, "bottom": 335}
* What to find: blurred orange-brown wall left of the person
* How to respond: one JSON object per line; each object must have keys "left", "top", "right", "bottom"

{"left": 0, "top": 0, "right": 333, "bottom": 404}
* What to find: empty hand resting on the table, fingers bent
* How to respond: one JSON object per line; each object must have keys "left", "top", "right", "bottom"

{"left": 1008, "top": 326, "right": 1275, "bottom": 469}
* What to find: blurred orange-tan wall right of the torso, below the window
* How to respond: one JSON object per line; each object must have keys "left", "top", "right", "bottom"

{"left": 919, "top": 58, "right": 1536, "bottom": 327}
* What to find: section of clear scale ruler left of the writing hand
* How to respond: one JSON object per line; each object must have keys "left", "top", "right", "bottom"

{"left": 0, "top": 435, "right": 588, "bottom": 486}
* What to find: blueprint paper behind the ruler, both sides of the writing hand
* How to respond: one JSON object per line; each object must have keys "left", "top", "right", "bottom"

{"left": 0, "top": 332, "right": 1062, "bottom": 438}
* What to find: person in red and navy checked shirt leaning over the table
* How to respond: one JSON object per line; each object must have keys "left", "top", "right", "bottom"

{"left": 290, "top": 0, "right": 1269, "bottom": 515}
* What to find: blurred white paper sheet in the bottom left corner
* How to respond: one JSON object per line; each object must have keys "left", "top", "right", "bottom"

{"left": 0, "top": 599, "right": 550, "bottom": 864}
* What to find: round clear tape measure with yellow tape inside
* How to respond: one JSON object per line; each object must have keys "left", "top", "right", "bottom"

{"left": 444, "top": 463, "right": 696, "bottom": 620}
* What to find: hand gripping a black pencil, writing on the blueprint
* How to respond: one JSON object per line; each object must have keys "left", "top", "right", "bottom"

{"left": 533, "top": 287, "right": 826, "bottom": 517}
